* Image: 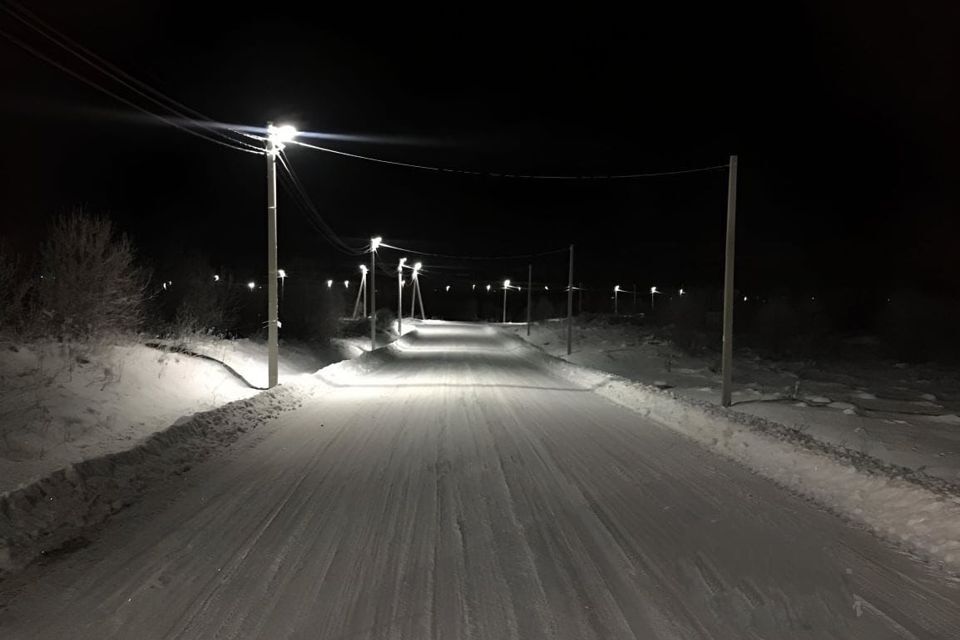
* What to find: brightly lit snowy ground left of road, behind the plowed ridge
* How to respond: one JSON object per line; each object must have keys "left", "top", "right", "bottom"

{"left": 0, "top": 338, "right": 332, "bottom": 494}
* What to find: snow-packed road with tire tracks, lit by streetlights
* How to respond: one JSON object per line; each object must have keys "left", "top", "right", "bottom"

{"left": 0, "top": 324, "right": 960, "bottom": 640}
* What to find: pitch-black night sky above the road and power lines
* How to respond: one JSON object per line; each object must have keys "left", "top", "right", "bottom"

{"left": 0, "top": 0, "right": 960, "bottom": 293}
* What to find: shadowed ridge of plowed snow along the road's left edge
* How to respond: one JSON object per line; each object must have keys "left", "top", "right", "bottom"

{"left": 0, "top": 386, "right": 301, "bottom": 576}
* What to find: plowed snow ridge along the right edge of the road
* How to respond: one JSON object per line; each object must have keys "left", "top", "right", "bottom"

{"left": 510, "top": 328, "right": 960, "bottom": 573}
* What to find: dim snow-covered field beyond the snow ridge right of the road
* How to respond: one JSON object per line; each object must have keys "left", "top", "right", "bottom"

{"left": 508, "top": 320, "right": 960, "bottom": 486}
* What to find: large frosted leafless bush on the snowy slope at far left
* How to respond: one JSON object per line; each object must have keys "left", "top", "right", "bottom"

{"left": 39, "top": 210, "right": 146, "bottom": 340}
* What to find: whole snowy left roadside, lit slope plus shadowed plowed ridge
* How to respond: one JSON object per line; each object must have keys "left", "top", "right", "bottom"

{"left": 0, "top": 340, "right": 334, "bottom": 573}
